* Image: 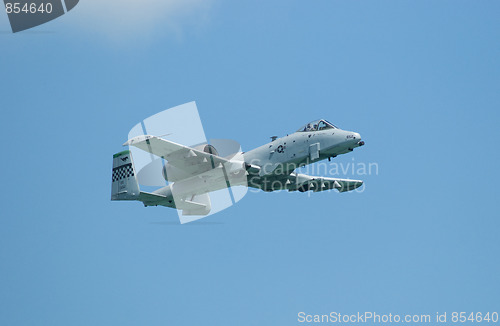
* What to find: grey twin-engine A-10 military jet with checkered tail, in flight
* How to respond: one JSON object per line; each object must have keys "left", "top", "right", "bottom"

{"left": 111, "top": 120, "right": 364, "bottom": 215}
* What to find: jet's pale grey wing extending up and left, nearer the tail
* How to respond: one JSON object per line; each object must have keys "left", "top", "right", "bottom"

{"left": 123, "top": 135, "right": 229, "bottom": 175}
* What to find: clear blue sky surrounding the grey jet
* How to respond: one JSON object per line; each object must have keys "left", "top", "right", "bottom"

{"left": 0, "top": 0, "right": 500, "bottom": 326}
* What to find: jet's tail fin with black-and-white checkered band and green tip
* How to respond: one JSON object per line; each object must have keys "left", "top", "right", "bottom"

{"left": 111, "top": 150, "right": 140, "bottom": 200}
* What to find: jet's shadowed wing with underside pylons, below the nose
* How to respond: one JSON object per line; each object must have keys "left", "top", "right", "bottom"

{"left": 288, "top": 173, "right": 363, "bottom": 192}
